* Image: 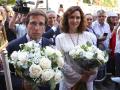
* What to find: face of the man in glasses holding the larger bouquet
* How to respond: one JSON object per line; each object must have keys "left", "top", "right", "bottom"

{"left": 27, "top": 15, "right": 45, "bottom": 40}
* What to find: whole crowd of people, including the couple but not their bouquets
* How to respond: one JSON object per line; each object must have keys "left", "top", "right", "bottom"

{"left": 0, "top": 6, "right": 120, "bottom": 90}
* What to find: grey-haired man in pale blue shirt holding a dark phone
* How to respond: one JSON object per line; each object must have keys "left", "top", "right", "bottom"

{"left": 92, "top": 10, "right": 111, "bottom": 50}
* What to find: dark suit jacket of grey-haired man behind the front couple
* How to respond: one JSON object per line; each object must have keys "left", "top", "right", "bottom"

{"left": 43, "top": 27, "right": 60, "bottom": 45}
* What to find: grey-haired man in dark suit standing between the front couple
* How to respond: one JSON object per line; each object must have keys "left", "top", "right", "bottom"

{"left": 43, "top": 10, "right": 60, "bottom": 45}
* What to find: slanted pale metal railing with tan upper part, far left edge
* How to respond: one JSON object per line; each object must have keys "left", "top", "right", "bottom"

{"left": 0, "top": 25, "right": 13, "bottom": 90}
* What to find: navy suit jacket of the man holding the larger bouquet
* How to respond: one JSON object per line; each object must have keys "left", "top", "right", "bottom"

{"left": 0, "top": 35, "right": 51, "bottom": 90}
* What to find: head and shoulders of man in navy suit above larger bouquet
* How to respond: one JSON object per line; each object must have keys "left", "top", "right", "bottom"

{"left": 7, "top": 10, "right": 52, "bottom": 55}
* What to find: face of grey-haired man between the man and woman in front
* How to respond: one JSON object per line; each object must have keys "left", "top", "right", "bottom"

{"left": 47, "top": 12, "right": 57, "bottom": 26}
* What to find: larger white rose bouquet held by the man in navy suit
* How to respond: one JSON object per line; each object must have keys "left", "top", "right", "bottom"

{"left": 10, "top": 41, "right": 64, "bottom": 89}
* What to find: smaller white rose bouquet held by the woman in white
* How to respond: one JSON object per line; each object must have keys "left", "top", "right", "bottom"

{"left": 69, "top": 42, "right": 108, "bottom": 70}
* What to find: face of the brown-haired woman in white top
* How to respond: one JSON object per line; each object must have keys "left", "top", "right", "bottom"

{"left": 68, "top": 11, "right": 81, "bottom": 32}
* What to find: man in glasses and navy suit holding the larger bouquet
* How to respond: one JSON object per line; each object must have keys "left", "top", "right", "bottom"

{"left": 0, "top": 10, "right": 51, "bottom": 90}
